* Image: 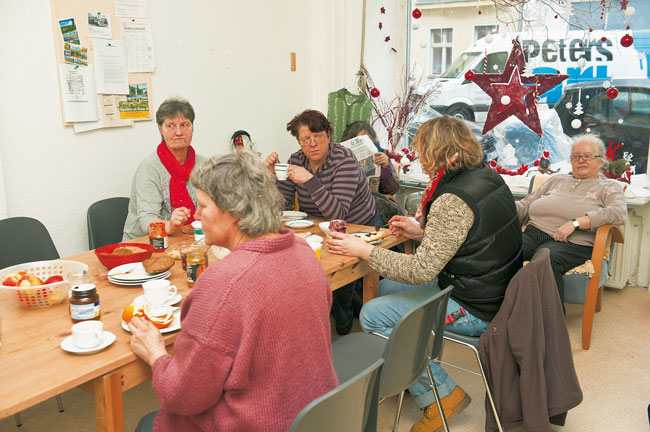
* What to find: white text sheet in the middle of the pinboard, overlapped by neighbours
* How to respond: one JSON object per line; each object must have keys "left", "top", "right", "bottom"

{"left": 95, "top": 39, "right": 129, "bottom": 94}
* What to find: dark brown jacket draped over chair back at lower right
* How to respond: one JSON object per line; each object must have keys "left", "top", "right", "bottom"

{"left": 479, "top": 249, "right": 582, "bottom": 432}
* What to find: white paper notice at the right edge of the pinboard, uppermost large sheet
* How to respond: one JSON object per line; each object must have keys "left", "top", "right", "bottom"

{"left": 120, "top": 18, "right": 156, "bottom": 72}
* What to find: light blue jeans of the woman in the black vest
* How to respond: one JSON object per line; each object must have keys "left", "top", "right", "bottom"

{"left": 359, "top": 279, "right": 490, "bottom": 408}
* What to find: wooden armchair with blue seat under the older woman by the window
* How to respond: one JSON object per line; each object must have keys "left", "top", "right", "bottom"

{"left": 522, "top": 176, "right": 624, "bottom": 349}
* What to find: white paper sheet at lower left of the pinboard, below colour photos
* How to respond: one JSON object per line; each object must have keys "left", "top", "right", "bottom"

{"left": 59, "top": 64, "right": 98, "bottom": 122}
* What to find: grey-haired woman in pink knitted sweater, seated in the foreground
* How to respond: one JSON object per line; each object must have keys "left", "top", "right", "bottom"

{"left": 129, "top": 151, "right": 337, "bottom": 431}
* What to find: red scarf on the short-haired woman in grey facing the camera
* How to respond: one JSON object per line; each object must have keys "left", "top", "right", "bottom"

{"left": 156, "top": 140, "right": 196, "bottom": 224}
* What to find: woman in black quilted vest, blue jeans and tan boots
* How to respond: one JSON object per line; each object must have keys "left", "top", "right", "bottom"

{"left": 328, "top": 116, "right": 522, "bottom": 432}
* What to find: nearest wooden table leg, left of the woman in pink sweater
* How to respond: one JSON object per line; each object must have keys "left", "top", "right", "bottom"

{"left": 93, "top": 372, "right": 124, "bottom": 432}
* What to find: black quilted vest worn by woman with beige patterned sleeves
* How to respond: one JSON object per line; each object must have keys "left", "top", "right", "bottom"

{"left": 425, "top": 165, "right": 522, "bottom": 321}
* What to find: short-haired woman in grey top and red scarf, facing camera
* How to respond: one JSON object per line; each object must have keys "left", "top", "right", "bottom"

{"left": 123, "top": 99, "right": 204, "bottom": 240}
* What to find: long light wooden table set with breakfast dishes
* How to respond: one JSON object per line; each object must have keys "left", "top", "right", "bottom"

{"left": 0, "top": 225, "right": 404, "bottom": 431}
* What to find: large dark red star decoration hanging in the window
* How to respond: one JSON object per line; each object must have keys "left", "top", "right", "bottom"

{"left": 466, "top": 40, "right": 569, "bottom": 136}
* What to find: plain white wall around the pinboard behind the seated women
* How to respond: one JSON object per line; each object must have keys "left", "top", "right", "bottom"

{"left": 0, "top": 0, "right": 403, "bottom": 256}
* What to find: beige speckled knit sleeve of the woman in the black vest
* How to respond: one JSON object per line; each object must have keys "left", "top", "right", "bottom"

{"left": 370, "top": 194, "right": 474, "bottom": 285}
